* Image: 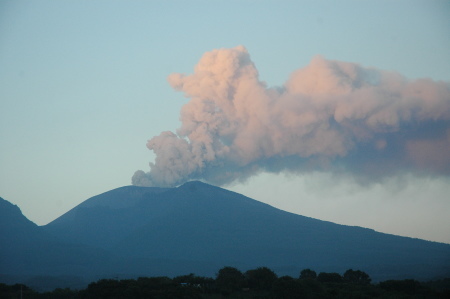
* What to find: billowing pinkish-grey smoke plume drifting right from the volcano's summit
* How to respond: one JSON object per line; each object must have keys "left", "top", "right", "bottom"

{"left": 132, "top": 46, "right": 450, "bottom": 186}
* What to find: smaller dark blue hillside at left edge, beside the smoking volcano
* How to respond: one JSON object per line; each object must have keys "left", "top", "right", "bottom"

{"left": 0, "top": 198, "right": 108, "bottom": 277}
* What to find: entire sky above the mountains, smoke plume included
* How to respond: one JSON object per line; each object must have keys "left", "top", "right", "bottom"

{"left": 0, "top": 1, "right": 450, "bottom": 243}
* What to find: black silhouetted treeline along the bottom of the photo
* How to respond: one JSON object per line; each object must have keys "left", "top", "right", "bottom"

{"left": 0, "top": 267, "right": 450, "bottom": 299}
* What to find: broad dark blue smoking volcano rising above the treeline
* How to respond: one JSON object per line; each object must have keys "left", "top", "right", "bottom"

{"left": 0, "top": 182, "right": 450, "bottom": 290}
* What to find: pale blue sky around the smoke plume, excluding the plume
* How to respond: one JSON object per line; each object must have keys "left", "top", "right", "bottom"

{"left": 0, "top": 1, "right": 450, "bottom": 243}
